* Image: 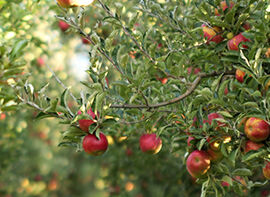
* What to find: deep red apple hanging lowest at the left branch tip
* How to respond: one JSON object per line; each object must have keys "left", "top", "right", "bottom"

{"left": 83, "top": 132, "right": 108, "bottom": 156}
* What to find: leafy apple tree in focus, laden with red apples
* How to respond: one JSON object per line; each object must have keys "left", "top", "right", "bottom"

{"left": 3, "top": 0, "right": 270, "bottom": 196}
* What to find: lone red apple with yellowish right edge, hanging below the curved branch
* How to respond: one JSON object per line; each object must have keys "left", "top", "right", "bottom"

{"left": 140, "top": 133, "right": 162, "bottom": 154}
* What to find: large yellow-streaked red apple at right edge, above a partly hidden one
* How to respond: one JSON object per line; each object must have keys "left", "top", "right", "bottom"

{"left": 245, "top": 117, "right": 270, "bottom": 142}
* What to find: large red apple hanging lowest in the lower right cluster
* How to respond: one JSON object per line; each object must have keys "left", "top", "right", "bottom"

{"left": 187, "top": 150, "right": 210, "bottom": 178}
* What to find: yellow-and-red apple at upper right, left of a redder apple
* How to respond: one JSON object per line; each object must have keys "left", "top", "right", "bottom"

{"left": 202, "top": 24, "right": 224, "bottom": 44}
